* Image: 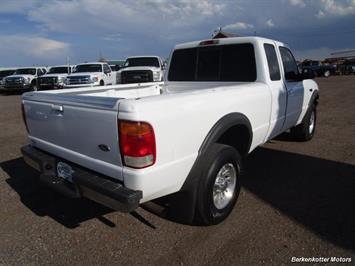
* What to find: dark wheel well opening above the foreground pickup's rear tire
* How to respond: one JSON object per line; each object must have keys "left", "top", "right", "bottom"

{"left": 216, "top": 125, "right": 250, "bottom": 156}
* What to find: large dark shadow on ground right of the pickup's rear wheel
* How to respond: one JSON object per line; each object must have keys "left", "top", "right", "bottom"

{"left": 242, "top": 148, "right": 355, "bottom": 250}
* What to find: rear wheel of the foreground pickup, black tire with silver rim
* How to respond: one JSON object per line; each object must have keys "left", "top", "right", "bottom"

{"left": 196, "top": 144, "right": 241, "bottom": 225}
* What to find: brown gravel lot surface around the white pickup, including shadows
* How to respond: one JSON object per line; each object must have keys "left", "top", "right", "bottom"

{"left": 0, "top": 76, "right": 355, "bottom": 265}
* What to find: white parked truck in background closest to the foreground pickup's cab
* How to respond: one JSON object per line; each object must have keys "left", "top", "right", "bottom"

{"left": 117, "top": 56, "right": 164, "bottom": 84}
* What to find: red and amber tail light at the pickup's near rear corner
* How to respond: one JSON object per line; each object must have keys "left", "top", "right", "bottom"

{"left": 118, "top": 121, "right": 156, "bottom": 168}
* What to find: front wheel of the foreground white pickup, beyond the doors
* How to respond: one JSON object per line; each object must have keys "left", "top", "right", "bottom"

{"left": 291, "top": 104, "right": 317, "bottom": 141}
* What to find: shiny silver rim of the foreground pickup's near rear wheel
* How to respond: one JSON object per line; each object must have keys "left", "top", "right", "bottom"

{"left": 213, "top": 163, "right": 237, "bottom": 210}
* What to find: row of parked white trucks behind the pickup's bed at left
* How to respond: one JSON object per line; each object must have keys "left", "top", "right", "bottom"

{"left": 0, "top": 56, "right": 164, "bottom": 91}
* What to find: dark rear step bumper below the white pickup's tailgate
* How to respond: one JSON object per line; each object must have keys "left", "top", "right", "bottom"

{"left": 21, "top": 145, "right": 142, "bottom": 212}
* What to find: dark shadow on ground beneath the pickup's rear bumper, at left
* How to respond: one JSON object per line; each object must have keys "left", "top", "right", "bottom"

{"left": 0, "top": 158, "right": 154, "bottom": 228}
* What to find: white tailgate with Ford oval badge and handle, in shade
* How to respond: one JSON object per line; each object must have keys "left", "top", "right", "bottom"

{"left": 23, "top": 93, "right": 123, "bottom": 180}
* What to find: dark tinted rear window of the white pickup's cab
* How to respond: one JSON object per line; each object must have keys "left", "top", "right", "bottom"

{"left": 168, "top": 43, "right": 256, "bottom": 82}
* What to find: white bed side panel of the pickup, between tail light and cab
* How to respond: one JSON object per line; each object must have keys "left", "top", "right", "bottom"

{"left": 119, "top": 82, "right": 271, "bottom": 201}
